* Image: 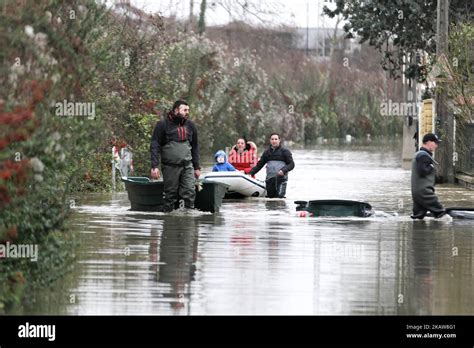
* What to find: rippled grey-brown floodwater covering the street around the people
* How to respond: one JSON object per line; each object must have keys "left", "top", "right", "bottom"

{"left": 13, "top": 148, "right": 474, "bottom": 315}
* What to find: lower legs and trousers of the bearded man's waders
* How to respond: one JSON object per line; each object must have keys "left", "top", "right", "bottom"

{"left": 161, "top": 165, "right": 196, "bottom": 211}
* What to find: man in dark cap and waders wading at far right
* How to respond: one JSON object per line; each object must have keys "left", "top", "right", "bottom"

{"left": 411, "top": 133, "right": 446, "bottom": 219}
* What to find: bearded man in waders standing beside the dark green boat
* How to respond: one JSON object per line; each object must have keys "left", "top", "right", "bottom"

{"left": 150, "top": 100, "right": 201, "bottom": 212}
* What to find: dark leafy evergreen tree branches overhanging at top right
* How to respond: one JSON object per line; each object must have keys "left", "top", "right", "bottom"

{"left": 324, "top": 0, "right": 474, "bottom": 82}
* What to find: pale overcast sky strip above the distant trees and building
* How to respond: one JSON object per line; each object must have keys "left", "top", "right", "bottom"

{"left": 126, "top": 0, "right": 335, "bottom": 27}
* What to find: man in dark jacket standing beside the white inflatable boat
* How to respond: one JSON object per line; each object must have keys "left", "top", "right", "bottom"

{"left": 249, "top": 133, "right": 295, "bottom": 198}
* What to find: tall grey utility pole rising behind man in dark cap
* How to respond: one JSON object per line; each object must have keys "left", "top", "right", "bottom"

{"left": 436, "top": 0, "right": 455, "bottom": 183}
